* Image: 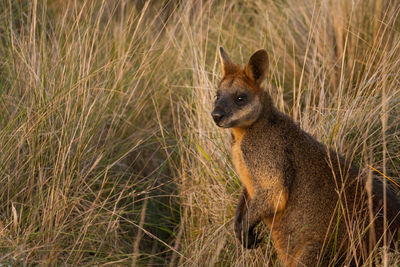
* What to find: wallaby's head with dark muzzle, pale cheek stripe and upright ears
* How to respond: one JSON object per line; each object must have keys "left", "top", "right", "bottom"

{"left": 211, "top": 47, "right": 268, "bottom": 128}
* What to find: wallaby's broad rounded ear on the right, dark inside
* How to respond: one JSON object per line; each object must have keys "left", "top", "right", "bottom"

{"left": 244, "top": 49, "right": 269, "bottom": 86}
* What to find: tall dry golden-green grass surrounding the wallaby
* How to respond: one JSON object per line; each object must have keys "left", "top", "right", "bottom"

{"left": 0, "top": 0, "right": 400, "bottom": 266}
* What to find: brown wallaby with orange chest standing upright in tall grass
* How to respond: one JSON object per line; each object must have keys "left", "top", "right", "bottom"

{"left": 212, "top": 47, "right": 400, "bottom": 266}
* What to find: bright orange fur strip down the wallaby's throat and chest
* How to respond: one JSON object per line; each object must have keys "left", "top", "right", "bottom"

{"left": 232, "top": 128, "right": 254, "bottom": 198}
